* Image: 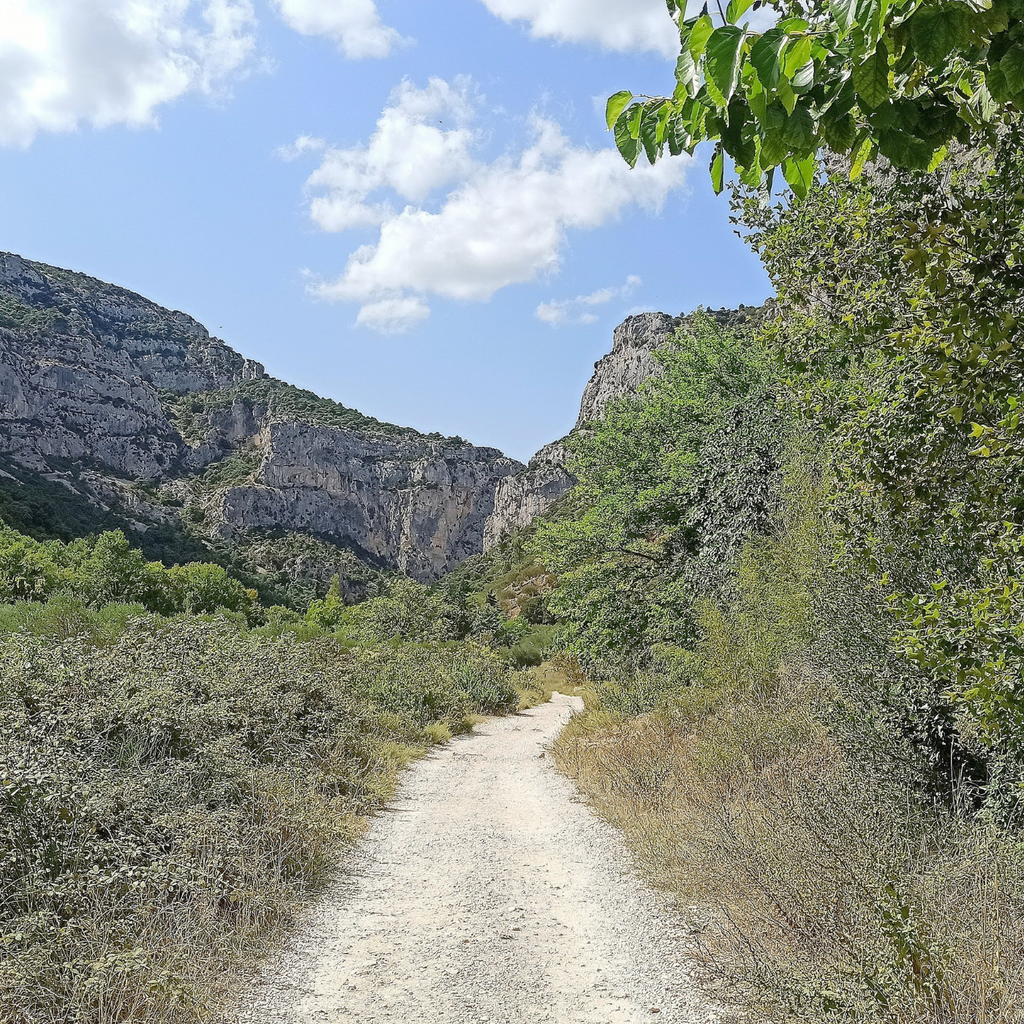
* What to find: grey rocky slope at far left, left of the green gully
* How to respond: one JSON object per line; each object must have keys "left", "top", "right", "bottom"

{"left": 0, "top": 255, "right": 263, "bottom": 480}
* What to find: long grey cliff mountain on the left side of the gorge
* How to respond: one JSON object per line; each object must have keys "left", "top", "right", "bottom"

{"left": 0, "top": 255, "right": 523, "bottom": 580}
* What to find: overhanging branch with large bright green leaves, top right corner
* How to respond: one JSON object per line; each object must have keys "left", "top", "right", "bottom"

{"left": 607, "top": 0, "right": 1024, "bottom": 198}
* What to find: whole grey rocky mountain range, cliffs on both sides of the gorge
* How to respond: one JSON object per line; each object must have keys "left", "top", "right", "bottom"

{"left": 0, "top": 254, "right": 756, "bottom": 599}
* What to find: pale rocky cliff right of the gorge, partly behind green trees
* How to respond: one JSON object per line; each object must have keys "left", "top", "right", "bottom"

{"left": 483, "top": 306, "right": 761, "bottom": 550}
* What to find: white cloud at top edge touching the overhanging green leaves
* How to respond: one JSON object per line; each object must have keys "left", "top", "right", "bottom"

{"left": 483, "top": 0, "right": 679, "bottom": 57}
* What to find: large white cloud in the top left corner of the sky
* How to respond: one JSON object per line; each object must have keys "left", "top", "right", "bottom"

{"left": 0, "top": 0, "right": 255, "bottom": 145}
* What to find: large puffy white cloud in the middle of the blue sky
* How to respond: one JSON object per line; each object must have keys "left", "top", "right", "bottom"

{"left": 294, "top": 80, "right": 689, "bottom": 332}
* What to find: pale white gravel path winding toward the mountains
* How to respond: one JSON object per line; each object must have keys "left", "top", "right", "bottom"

{"left": 229, "top": 694, "right": 716, "bottom": 1024}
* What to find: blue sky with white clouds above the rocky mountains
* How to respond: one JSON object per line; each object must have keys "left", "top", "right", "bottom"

{"left": 0, "top": 0, "right": 770, "bottom": 460}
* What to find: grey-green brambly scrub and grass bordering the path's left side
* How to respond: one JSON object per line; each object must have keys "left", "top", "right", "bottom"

{"left": 0, "top": 609, "right": 518, "bottom": 1024}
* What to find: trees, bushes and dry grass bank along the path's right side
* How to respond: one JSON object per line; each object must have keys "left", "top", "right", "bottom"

{"left": 483, "top": 121, "right": 1024, "bottom": 1024}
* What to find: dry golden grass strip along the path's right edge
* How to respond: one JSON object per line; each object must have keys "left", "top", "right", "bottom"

{"left": 554, "top": 670, "right": 1024, "bottom": 1024}
